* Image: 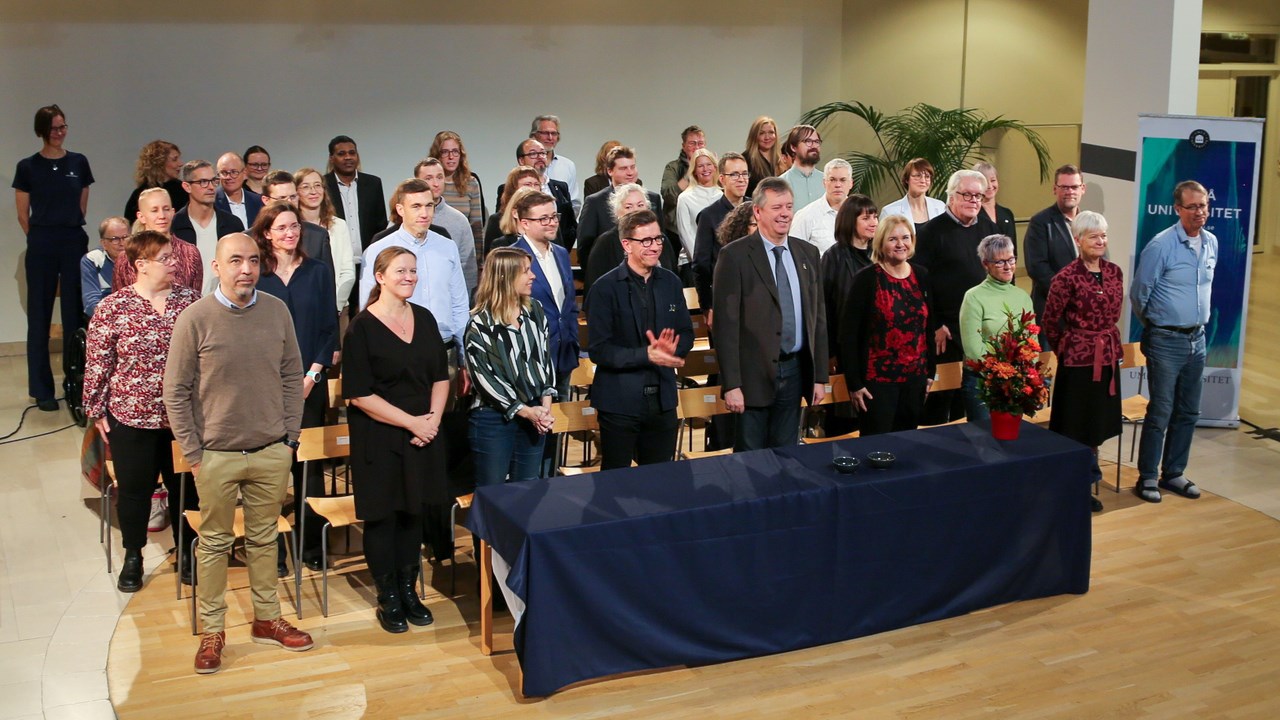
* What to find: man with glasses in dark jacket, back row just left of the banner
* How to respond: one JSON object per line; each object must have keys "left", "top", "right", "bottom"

{"left": 1023, "top": 165, "right": 1084, "bottom": 350}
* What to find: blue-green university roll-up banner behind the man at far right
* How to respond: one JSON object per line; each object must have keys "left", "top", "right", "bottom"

{"left": 1129, "top": 115, "right": 1263, "bottom": 428}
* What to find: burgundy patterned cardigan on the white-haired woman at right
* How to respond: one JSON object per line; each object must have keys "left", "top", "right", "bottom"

{"left": 1041, "top": 259, "right": 1124, "bottom": 371}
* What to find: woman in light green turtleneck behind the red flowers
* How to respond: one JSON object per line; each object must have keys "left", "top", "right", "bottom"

{"left": 960, "top": 234, "right": 1033, "bottom": 423}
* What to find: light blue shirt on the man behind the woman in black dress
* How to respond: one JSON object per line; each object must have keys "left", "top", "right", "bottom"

{"left": 360, "top": 225, "right": 470, "bottom": 365}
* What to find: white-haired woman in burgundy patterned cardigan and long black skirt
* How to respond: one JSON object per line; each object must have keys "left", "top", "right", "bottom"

{"left": 1041, "top": 210, "right": 1124, "bottom": 511}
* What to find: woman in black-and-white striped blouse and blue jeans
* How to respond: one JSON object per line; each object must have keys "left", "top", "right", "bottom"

{"left": 466, "top": 247, "right": 556, "bottom": 486}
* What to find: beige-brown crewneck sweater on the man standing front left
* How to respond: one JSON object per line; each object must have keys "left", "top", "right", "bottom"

{"left": 164, "top": 292, "right": 302, "bottom": 465}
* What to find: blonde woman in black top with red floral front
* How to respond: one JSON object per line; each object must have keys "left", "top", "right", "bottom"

{"left": 840, "top": 215, "right": 937, "bottom": 436}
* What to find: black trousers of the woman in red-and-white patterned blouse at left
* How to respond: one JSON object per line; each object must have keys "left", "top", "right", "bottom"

{"left": 106, "top": 414, "right": 200, "bottom": 550}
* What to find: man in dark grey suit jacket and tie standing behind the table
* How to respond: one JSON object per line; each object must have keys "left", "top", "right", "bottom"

{"left": 712, "top": 178, "right": 828, "bottom": 451}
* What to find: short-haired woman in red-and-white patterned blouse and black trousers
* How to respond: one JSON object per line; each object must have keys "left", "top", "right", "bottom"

{"left": 84, "top": 231, "right": 200, "bottom": 592}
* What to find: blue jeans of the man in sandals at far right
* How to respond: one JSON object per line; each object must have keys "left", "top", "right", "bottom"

{"left": 1138, "top": 328, "right": 1204, "bottom": 480}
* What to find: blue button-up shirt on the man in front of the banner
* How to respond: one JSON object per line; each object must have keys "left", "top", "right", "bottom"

{"left": 1129, "top": 223, "right": 1217, "bottom": 328}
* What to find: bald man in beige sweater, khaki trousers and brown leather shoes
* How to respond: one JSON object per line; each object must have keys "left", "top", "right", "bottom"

{"left": 164, "top": 233, "right": 312, "bottom": 674}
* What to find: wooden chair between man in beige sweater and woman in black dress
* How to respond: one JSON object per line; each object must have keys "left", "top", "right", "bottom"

{"left": 293, "top": 424, "right": 358, "bottom": 620}
